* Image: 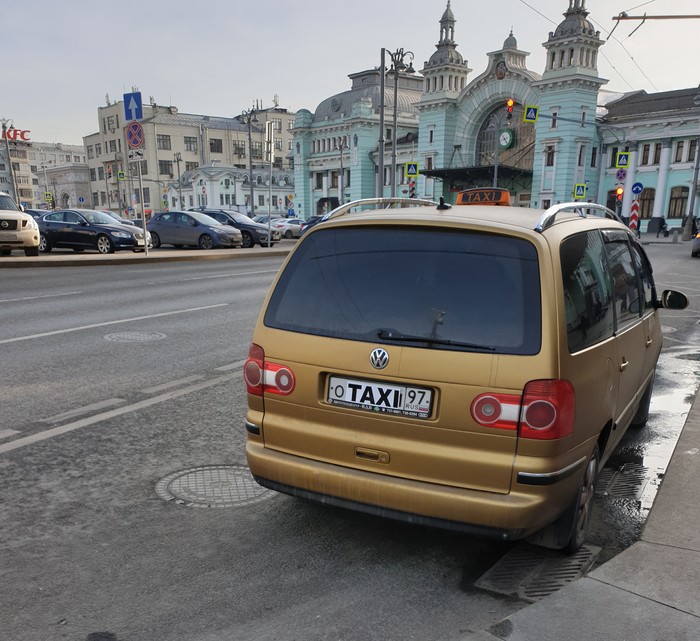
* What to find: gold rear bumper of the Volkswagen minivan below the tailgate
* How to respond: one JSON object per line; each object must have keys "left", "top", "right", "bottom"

{"left": 246, "top": 438, "right": 578, "bottom": 540}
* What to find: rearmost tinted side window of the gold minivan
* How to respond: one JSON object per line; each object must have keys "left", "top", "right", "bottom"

{"left": 561, "top": 231, "right": 614, "bottom": 353}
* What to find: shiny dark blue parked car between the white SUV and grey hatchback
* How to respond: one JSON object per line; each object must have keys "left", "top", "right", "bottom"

{"left": 38, "top": 209, "right": 145, "bottom": 254}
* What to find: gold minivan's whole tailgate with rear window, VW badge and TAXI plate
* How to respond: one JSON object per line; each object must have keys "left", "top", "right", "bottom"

{"left": 260, "top": 225, "right": 549, "bottom": 493}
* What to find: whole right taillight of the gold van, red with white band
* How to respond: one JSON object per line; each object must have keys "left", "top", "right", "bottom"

{"left": 470, "top": 380, "right": 575, "bottom": 439}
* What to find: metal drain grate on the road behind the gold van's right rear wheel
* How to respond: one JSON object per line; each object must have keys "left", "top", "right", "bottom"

{"left": 474, "top": 543, "right": 600, "bottom": 603}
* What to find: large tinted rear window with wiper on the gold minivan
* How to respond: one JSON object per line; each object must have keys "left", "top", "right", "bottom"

{"left": 264, "top": 226, "right": 541, "bottom": 354}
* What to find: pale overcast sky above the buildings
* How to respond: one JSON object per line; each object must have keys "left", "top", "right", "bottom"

{"left": 5, "top": 0, "right": 700, "bottom": 144}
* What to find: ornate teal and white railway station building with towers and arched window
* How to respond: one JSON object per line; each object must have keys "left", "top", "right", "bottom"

{"left": 290, "top": 0, "right": 700, "bottom": 227}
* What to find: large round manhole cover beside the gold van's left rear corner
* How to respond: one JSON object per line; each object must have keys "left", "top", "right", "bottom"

{"left": 156, "top": 465, "right": 273, "bottom": 507}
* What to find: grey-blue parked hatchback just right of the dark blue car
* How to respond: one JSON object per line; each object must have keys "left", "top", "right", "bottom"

{"left": 146, "top": 211, "right": 243, "bottom": 249}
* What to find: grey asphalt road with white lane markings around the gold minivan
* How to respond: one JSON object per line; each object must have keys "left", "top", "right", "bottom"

{"left": 0, "top": 241, "right": 700, "bottom": 641}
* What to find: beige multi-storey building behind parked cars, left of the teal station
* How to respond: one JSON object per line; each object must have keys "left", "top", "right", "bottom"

{"left": 83, "top": 98, "right": 295, "bottom": 216}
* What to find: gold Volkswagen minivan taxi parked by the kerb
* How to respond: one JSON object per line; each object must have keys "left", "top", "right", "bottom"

{"left": 244, "top": 199, "right": 688, "bottom": 552}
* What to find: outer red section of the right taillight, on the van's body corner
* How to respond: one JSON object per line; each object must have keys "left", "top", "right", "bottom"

{"left": 520, "top": 380, "right": 576, "bottom": 439}
